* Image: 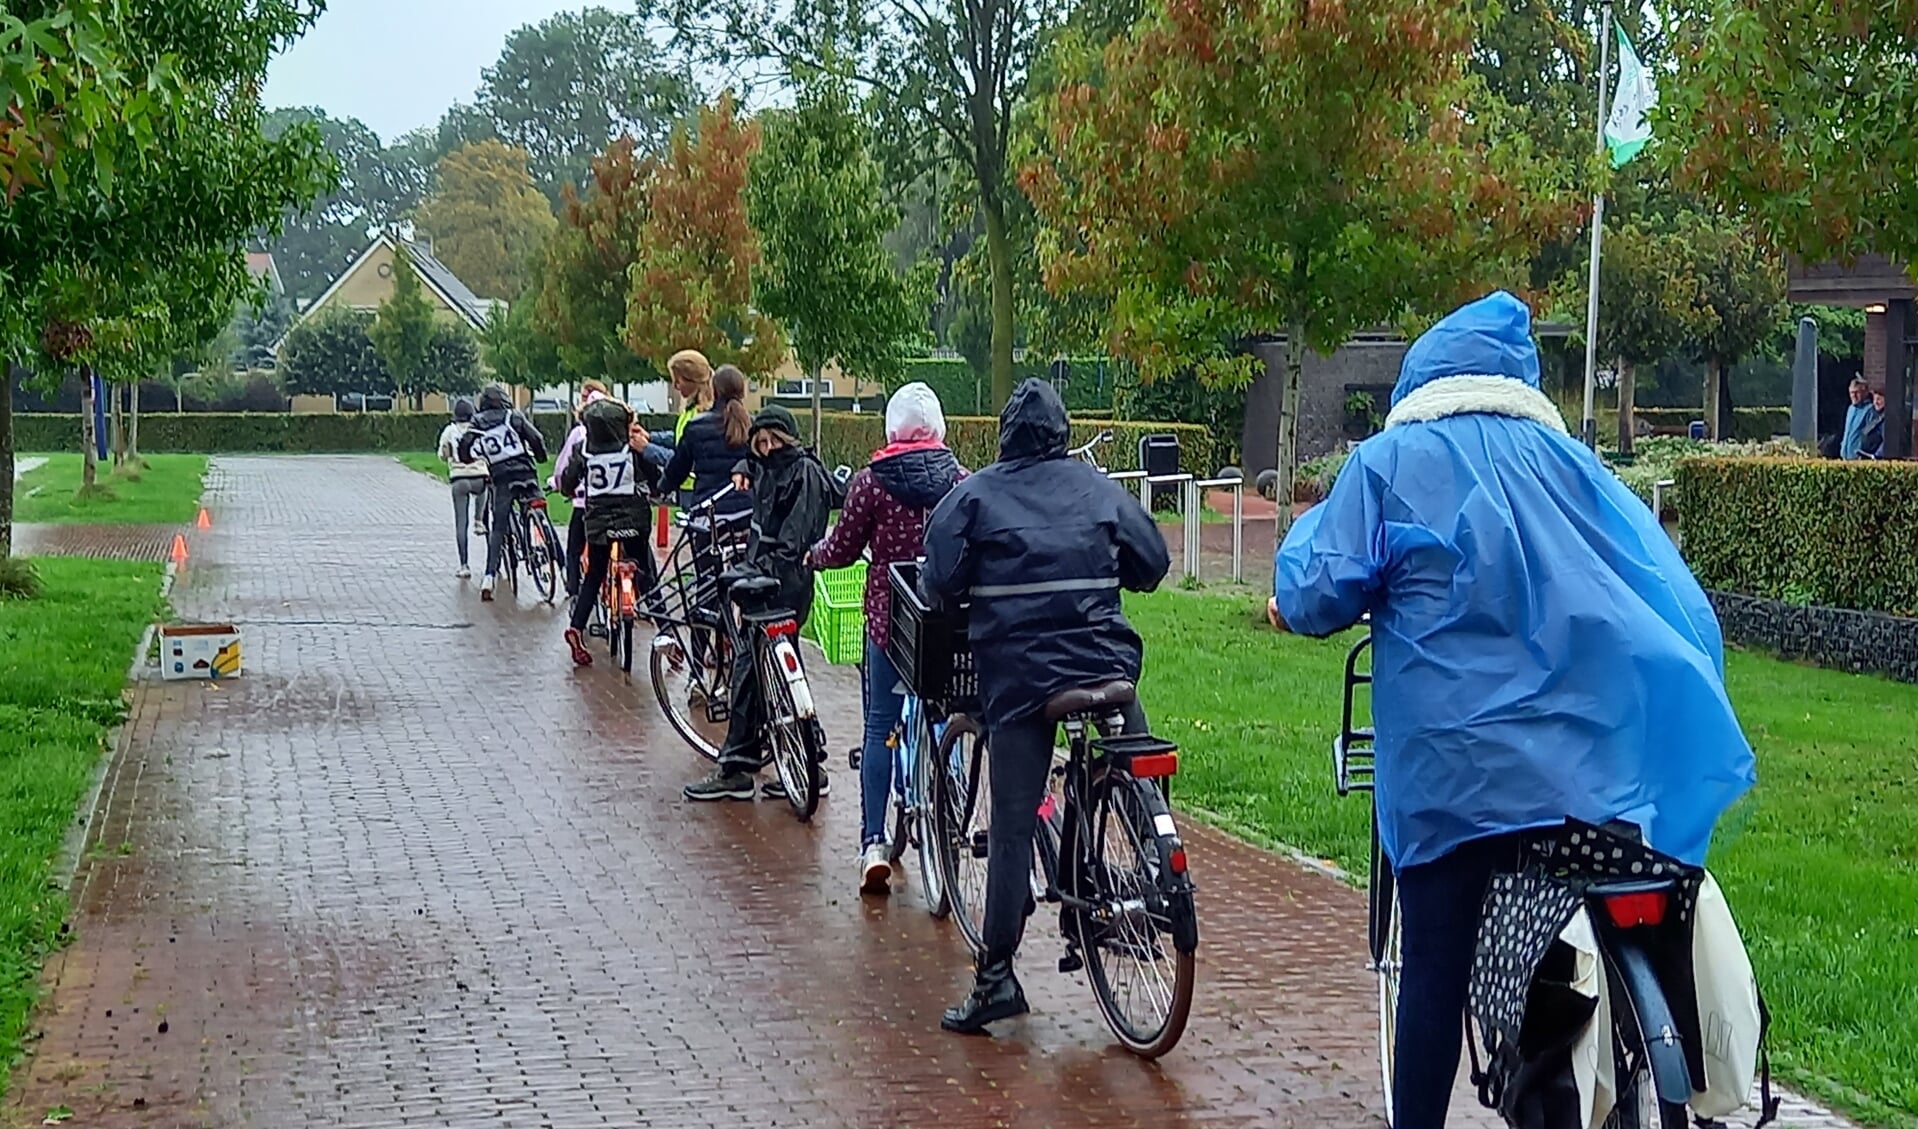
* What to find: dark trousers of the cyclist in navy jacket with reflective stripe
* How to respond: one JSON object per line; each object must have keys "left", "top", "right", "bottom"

{"left": 982, "top": 703, "right": 1149, "bottom": 958}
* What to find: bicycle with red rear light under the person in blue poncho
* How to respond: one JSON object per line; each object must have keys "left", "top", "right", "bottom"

{"left": 1333, "top": 633, "right": 1770, "bottom": 1129}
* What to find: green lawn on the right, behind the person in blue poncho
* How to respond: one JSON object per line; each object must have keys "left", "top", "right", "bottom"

{"left": 1126, "top": 590, "right": 1918, "bottom": 1129}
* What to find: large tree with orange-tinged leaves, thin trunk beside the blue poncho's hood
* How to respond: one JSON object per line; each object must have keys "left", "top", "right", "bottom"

{"left": 1020, "top": 0, "right": 1577, "bottom": 516}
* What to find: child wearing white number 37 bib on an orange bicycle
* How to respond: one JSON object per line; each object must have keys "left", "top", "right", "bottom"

{"left": 560, "top": 399, "right": 660, "bottom": 667}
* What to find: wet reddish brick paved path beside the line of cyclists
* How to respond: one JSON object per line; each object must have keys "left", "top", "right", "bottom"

{"left": 12, "top": 456, "right": 1841, "bottom": 1129}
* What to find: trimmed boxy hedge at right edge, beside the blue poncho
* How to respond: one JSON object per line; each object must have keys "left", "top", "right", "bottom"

{"left": 1678, "top": 458, "right": 1918, "bottom": 615}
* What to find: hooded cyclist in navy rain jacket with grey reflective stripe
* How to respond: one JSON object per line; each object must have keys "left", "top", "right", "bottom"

{"left": 919, "top": 380, "right": 1172, "bottom": 1033}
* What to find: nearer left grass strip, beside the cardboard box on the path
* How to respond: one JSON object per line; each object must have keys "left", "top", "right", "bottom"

{"left": 0, "top": 558, "right": 161, "bottom": 1087}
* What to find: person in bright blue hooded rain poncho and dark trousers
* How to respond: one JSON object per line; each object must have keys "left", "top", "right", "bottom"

{"left": 1274, "top": 293, "right": 1753, "bottom": 1129}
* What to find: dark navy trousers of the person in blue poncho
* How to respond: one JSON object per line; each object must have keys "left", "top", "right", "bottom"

{"left": 1392, "top": 836, "right": 1519, "bottom": 1129}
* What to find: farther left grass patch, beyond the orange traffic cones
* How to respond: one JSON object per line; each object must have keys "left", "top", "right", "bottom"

{"left": 13, "top": 454, "right": 207, "bottom": 525}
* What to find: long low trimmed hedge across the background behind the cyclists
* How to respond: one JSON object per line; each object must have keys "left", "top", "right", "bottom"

{"left": 13, "top": 412, "right": 1218, "bottom": 475}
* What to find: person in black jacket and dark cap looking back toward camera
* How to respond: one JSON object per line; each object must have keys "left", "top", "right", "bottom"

{"left": 690, "top": 402, "right": 838, "bottom": 799}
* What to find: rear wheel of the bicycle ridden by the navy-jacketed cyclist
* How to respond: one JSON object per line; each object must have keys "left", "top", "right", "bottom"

{"left": 1068, "top": 774, "right": 1199, "bottom": 1058}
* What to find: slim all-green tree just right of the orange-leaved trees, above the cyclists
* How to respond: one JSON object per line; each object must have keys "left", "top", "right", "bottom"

{"left": 746, "top": 81, "right": 932, "bottom": 443}
